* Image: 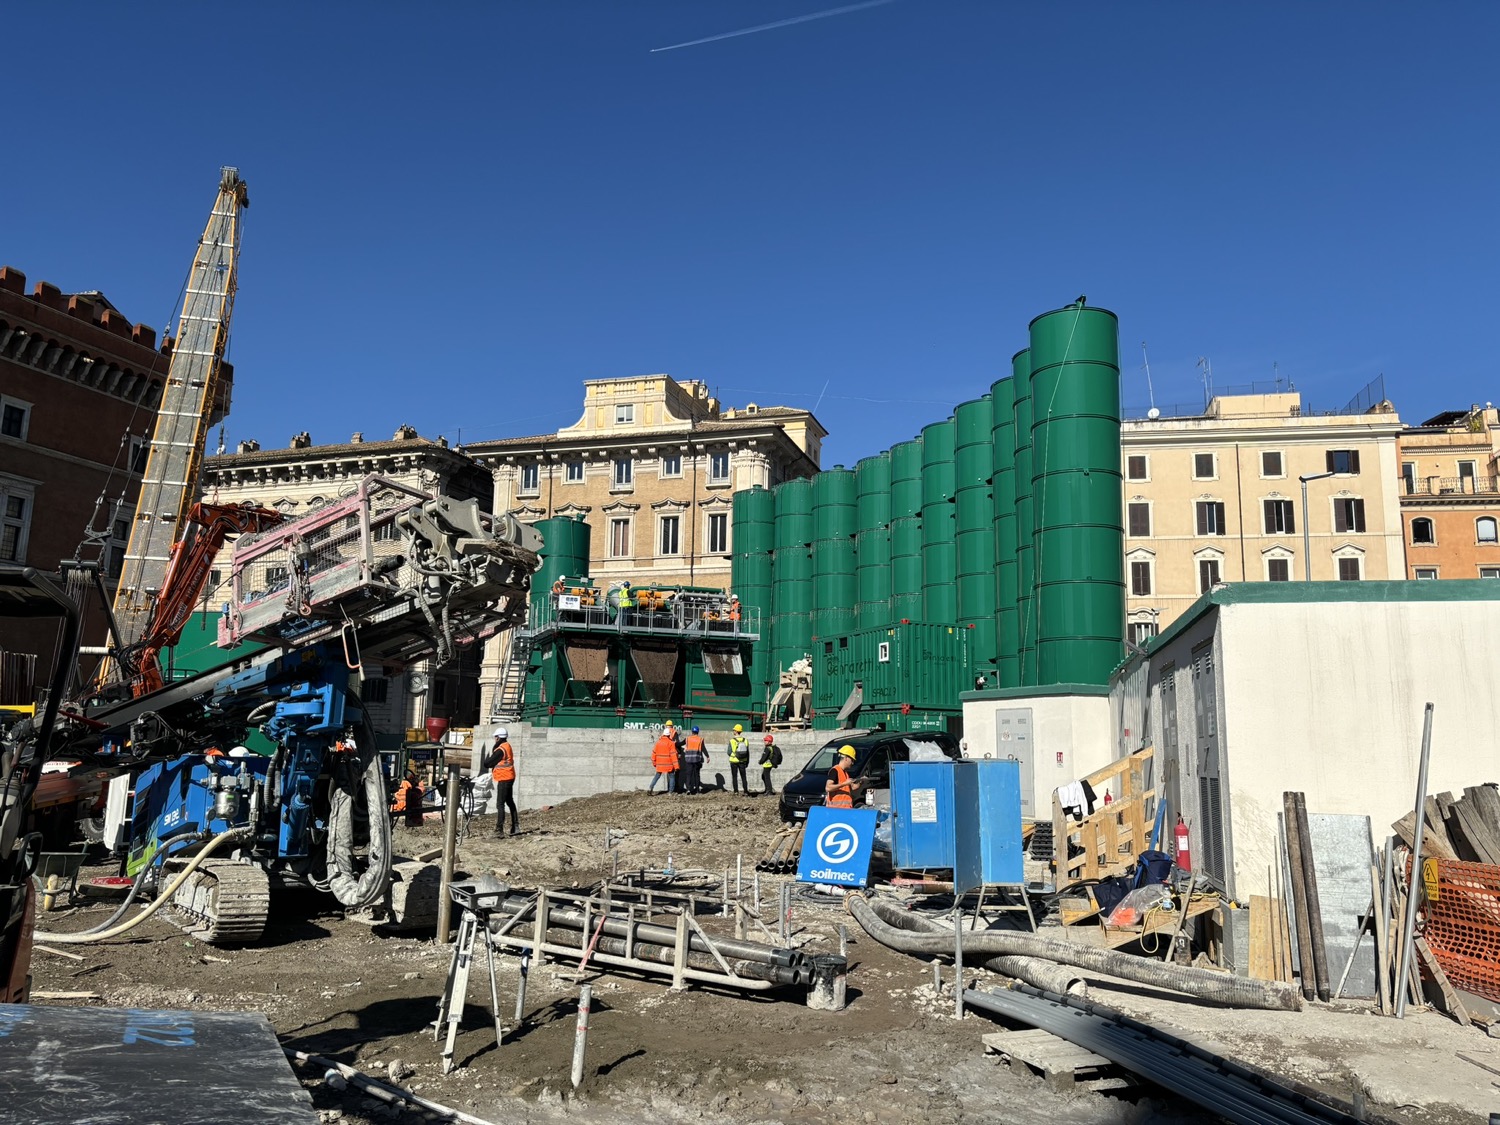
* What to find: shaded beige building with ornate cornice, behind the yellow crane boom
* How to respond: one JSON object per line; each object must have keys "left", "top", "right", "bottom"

{"left": 203, "top": 426, "right": 492, "bottom": 747}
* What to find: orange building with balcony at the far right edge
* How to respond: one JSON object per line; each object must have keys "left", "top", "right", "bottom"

{"left": 1401, "top": 402, "right": 1500, "bottom": 579}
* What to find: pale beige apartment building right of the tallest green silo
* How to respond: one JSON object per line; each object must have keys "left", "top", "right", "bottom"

{"left": 1121, "top": 392, "right": 1406, "bottom": 641}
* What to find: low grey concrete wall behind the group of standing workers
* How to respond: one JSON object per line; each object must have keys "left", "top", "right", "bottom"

{"left": 474, "top": 723, "right": 854, "bottom": 809}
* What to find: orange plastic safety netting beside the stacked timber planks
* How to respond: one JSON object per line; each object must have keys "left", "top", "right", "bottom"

{"left": 1422, "top": 860, "right": 1500, "bottom": 1001}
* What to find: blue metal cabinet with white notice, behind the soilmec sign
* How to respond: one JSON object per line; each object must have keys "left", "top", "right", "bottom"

{"left": 891, "top": 759, "right": 1026, "bottom": 890}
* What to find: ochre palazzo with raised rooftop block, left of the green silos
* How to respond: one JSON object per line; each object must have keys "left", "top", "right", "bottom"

{"left": 467, "top": 375, "right": 828, "bottom": 587}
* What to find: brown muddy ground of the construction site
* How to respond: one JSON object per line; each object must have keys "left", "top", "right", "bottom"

{"left": 33, "top": 794, "right": 1494, "bottom": 1125}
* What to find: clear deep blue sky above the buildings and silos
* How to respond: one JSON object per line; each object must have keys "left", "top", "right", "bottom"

{"left": 0, "top": 0, "right": 1500, "bottom": 465}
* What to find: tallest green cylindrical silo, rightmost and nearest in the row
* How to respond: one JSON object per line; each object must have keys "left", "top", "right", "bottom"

{"left": 1031, "top": 302, "right": 1125, "bottom": 684}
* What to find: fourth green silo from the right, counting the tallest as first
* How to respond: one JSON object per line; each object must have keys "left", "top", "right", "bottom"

{"left": 953, "top": 395, "right": 996, "bottom": 677}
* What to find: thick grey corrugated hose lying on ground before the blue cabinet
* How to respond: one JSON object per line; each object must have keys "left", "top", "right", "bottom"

{"left": 845, "top": 893, "right": 1302, "bottom": 1011}
